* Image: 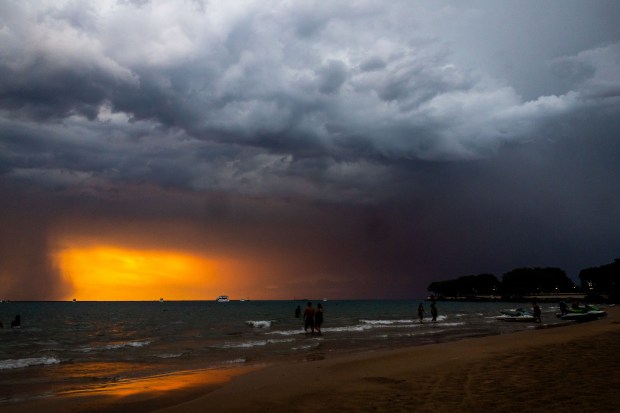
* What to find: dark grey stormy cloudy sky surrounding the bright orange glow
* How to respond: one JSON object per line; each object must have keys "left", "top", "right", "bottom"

{"left": 0, "top": 0, "right": 620, "bottom": 299}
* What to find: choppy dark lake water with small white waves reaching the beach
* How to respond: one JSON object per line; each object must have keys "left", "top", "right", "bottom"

{"left": 0, "top": 300, "right": 557, "bottom": 403}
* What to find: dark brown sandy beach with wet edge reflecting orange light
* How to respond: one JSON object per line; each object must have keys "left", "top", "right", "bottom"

{"left": 6, "top": 307, "right": 620, "bottom": 413}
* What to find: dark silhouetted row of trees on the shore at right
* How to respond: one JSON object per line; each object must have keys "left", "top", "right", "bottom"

{"left": 427, "top": 259, "right": 620, "bottom": 302}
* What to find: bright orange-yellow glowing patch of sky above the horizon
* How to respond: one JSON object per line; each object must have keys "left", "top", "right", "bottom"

{"left": 58, "top": 246, "right": 234, "bottom": 301}
